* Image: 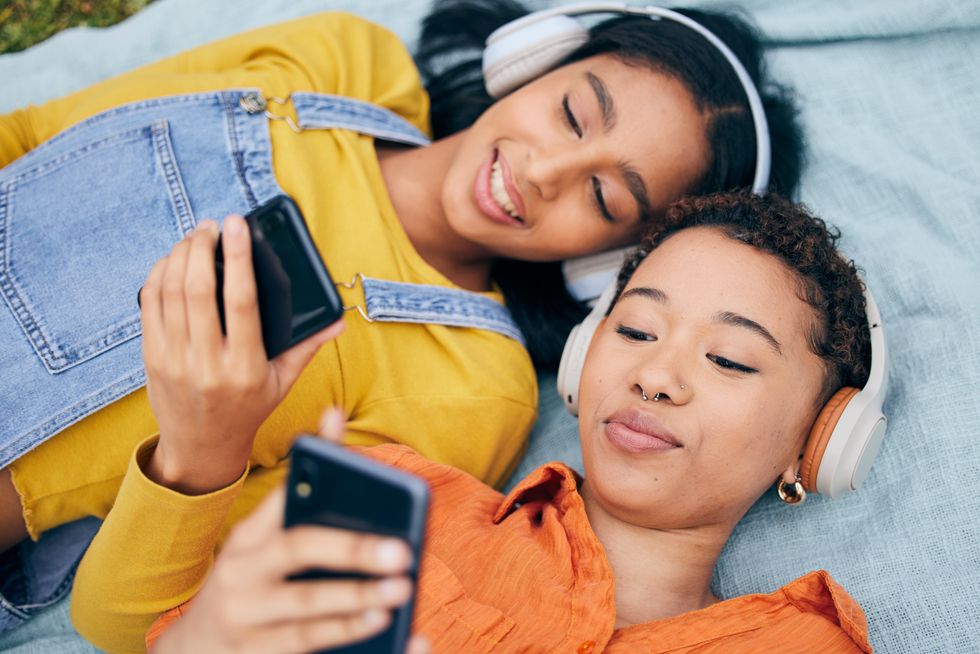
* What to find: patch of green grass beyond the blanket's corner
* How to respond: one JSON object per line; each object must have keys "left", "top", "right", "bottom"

{"left": 0, "top": 0, "right": 153, "bottom": 53}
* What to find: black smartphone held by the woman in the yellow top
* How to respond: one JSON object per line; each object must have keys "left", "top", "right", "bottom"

{"left": 136, "top": 195, "right": 344, "bottom": 359}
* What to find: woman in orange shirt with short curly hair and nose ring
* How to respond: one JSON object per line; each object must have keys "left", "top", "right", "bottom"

{"left": 147, "top": 194, "right": 871, "bottom": 654}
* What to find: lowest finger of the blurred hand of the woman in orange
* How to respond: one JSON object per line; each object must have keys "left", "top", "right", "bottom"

{"left": 247, "top": 609, "right": 391, "bottom": 654}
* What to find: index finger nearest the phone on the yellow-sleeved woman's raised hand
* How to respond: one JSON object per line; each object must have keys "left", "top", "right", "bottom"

{"left": 221, "top": 215, "right": 265, "bottom": 360}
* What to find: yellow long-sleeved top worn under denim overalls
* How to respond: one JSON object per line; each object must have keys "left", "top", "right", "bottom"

{"left": 0, "top": 14, "right": 537, "bottom": 651}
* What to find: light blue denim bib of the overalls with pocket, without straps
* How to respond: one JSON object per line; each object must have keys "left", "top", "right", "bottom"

{"left": 0, "top": 91, "right": 281, "bottom": 466}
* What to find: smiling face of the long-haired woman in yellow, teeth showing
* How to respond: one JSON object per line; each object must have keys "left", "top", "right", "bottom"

{"left": 442, "top": 55, "right": 709, "bottom": 261}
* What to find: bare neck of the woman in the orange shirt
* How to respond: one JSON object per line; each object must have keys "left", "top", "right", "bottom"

{"left": 582, "top": 480, "right": 734, "bottom": 629}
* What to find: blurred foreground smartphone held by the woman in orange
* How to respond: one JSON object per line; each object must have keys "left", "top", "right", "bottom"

{"left": 286, "top": 436, "right": 429, "bottom": 654}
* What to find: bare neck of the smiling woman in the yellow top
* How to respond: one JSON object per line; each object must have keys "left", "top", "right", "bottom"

{"left": 378, "top": 132, "right": 492, "bottom": 291}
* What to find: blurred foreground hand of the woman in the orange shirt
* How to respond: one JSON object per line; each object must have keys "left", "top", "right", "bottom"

{"left": 151, "top": 468, "right": 429, "bottom": 654}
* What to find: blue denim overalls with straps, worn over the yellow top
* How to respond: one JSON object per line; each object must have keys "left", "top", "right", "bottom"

{"left": 0, "top": 89, "right": 522, "bottom": 631}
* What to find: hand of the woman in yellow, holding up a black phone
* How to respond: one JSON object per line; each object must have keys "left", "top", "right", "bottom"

{"left": 141, "top": 216, "right": 343, "bottom": 494}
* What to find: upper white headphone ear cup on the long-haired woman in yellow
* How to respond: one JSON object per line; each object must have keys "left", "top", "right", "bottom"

{"left": 483, "top": 16, "right": 589, "bottom": 98}
